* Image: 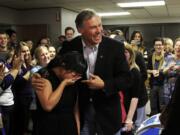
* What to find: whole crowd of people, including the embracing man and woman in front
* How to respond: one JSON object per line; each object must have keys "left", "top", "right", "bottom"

{"left": 0, "top": 9, "right": 180, "bottom": 135}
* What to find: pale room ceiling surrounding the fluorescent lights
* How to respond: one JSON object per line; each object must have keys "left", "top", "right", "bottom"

{"left": 0, "top": 0, "right": 180, "bottom": 19}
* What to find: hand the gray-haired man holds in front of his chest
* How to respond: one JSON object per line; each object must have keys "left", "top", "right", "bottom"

{"left": 82, "top": 74, "right": 104, "bottom": 89}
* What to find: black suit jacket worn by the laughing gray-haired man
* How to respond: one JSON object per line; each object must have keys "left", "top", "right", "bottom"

{"left": 60, "top": 36, "right": 130, "bottom": 135}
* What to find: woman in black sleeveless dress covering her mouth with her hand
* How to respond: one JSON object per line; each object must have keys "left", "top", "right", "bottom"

{"left": 32, "top": 52, "right": 87, "bottom": 135}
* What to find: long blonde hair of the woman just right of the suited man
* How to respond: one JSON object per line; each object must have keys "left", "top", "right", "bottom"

{"left": 125, "top": 44, "right": 140, "bottom": 70}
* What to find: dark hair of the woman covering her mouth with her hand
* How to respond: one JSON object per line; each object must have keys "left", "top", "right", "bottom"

{"left": 47, "top": 51, "right": 87, "bottom": 74}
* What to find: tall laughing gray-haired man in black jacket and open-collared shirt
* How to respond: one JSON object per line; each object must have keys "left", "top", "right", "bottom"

{"left": 59, "top": 9, "right": 130, "bottom": 135}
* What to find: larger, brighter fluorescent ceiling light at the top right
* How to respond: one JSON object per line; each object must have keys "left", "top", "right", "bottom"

{"left": 117, "top": 1, "right": 165, "bottom": 8}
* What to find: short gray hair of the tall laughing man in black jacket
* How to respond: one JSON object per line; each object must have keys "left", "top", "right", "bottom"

{"left": 75, "top": 9, "right": 98, "bottom": 29}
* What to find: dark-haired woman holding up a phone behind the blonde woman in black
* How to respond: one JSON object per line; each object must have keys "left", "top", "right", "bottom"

{"left": 131, "top": 31, "right": 148, "bottom": 129}
